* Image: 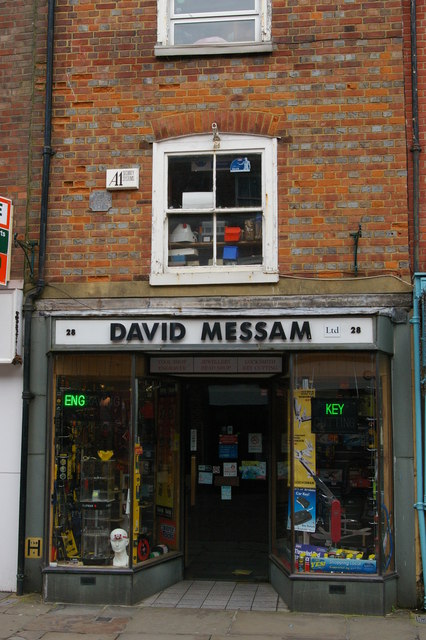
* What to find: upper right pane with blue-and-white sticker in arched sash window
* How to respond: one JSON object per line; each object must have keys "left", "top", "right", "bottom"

{"left": 216, "top": 153, "right": 262, "bottom": 208}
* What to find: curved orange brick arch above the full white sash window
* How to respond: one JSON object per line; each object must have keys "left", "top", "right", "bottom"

{"left": 152, "top": 109, "right": 286, "bottom": 142}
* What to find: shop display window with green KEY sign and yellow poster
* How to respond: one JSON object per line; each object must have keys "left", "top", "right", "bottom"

{"left": 273, "top": 353, "right": 394, "bottom": 575}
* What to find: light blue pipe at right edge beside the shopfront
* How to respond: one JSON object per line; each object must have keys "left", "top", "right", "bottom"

{"left": 411, "top": 274, "right": 426, "bottom": 609}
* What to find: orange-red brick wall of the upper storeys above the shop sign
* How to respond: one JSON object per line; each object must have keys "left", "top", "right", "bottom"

{"left": 25, "top": 0, "right": 409, "bottom": 283}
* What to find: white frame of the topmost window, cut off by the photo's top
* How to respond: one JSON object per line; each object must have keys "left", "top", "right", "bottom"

{"left": 155, "top": 0, "right": 272, "bottom": 56}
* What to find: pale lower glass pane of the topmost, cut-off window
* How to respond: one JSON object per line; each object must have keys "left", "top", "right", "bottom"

{"left": 174, "top": 20, "right": 256, "bottom": 44}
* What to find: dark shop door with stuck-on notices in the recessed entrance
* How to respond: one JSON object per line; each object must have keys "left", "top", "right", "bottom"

{"left": 183, "top": 382, "right": 269, "bottom": 581}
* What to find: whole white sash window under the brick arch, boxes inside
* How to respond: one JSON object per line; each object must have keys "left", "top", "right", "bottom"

{"left": 151, "top": 134, "right": 278, "bottom": 285}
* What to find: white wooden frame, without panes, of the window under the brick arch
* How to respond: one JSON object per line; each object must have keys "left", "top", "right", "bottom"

{"left": 150, "top": 133, "right": 279, "bottom": 285}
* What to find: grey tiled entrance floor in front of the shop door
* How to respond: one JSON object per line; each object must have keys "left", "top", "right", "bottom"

{"left": 140, "top": 580, "right": 287, "bottom": 611}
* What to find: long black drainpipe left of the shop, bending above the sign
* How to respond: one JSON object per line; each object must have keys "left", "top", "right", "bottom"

{"left": 16, "top": 0, "right": 55, "bottom": 596}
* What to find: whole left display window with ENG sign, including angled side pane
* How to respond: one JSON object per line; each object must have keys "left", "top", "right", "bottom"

{"left": 49, "top": 355, "right": 180, "bottom": 568}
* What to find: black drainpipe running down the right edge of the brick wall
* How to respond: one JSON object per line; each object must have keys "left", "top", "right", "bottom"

{"left": 410, "top": 0, "right": 422, "bottom": 273}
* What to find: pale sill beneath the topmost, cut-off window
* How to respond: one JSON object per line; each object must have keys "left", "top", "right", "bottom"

{"left": 154, "top": 41, "right": 273, "bottom": 57}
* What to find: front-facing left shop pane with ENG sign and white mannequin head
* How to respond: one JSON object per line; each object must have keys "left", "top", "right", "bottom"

{"left": 50, "top": 356, "right": 131, "bottom": 566}
